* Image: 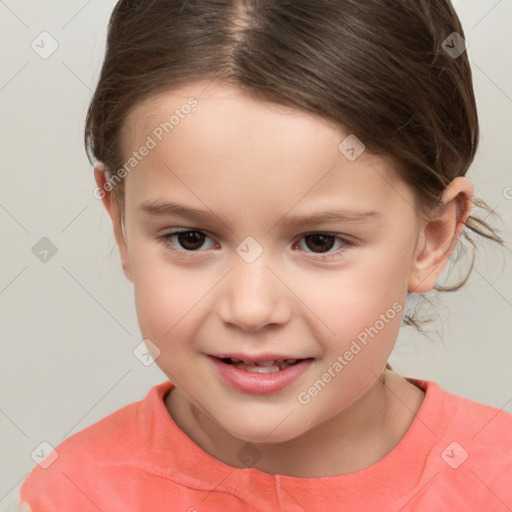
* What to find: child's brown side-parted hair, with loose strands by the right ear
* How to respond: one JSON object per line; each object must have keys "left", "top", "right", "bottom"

{"left": 85, "top": 0, "right": 504, "bottom": 331}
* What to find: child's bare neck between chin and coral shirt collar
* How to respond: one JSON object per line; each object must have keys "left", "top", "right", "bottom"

{"left": 166, "top": 370, "right": 424, "bottom": 478}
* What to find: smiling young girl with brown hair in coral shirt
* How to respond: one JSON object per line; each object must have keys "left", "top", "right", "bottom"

{"left": 20, "top": 0, "right": 512, "bottom": 512}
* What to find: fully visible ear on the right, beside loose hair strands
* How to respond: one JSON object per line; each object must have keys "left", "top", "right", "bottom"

{"left": 408, "top": 176, "right": 473, "bottom": 293}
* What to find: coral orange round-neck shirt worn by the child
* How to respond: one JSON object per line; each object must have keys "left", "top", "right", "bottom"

{"left": 20, "top": 378, "right": 512, "bottom": 512}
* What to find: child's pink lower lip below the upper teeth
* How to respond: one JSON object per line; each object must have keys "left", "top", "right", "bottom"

{"left": 210, "top": 356, "right": 313, "bottom": 395}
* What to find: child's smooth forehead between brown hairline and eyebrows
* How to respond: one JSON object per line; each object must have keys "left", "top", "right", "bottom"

{"left": 118, "top": 82, "right": 412, "bottom": 218}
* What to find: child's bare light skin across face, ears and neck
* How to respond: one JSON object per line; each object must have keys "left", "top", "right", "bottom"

{"left": 95, "top": 82, "right": 473, "bottom": 477}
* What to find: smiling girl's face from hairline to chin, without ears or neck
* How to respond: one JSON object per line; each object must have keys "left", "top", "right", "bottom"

{"left": 104, "top": 82, "right": 436, "bottom": 442}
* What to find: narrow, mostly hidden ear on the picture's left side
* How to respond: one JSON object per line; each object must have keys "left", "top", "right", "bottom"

{"left": 94, "top": 162, "right": 133, "bottom": 283}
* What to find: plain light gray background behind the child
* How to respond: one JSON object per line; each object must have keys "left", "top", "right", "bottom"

{"left": 0, "top": 0, "right": 512, "bottom": 507}
